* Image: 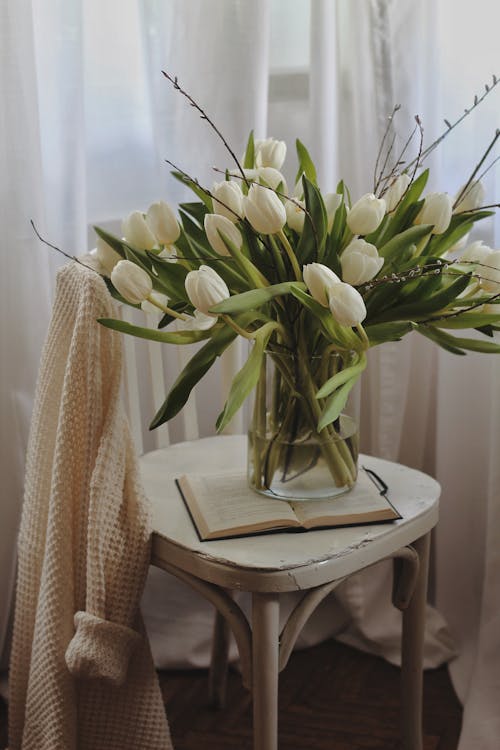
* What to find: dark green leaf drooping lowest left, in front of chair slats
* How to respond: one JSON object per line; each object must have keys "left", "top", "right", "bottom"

{"left": 149, "top": 326, "right": 237, "bottom": 430}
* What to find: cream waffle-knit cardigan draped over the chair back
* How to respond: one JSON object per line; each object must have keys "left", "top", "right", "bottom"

{"left": 9, "top": 263, "right": 172, "bottom": 750}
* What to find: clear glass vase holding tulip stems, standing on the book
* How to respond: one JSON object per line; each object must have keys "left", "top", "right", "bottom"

{"left": 248, "top": 351, "right": 359, "bottom": 500}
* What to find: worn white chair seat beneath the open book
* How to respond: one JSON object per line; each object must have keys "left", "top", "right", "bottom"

{"left": 140, "top": 435, "right": 440, "bottom": 592}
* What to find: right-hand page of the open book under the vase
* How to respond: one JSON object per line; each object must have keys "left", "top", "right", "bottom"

{"left": 290, "top": 470, "right": 400, "bottom": 528}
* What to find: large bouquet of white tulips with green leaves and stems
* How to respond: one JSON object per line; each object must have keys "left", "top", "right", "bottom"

{"left": 94, "top": 76, "right": 500, "bottom": 500}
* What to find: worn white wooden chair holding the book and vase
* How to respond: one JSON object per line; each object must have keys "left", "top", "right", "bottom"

{"left": 124, "top": 306, "right": 440, "bottom": 750}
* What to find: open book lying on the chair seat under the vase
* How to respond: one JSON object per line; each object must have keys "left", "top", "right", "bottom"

{"left": 176, "top": 471, "right": 401, "bottom": 541}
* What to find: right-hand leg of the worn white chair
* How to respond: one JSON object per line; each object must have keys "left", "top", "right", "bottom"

{"left": 401, "top": 534, "right": 430, "bottom": 750}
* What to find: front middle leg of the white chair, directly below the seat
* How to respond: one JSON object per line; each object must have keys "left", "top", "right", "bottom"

{"left": 252, "top": 594, "right": 279, "bottom": 750}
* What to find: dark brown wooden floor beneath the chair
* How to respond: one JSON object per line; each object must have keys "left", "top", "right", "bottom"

{"left": 0, "top": 641, "right": 461, "bottom": 750}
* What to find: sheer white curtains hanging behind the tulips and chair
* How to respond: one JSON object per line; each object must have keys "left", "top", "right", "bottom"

{"left": 0, "top": 0, "right": 500, "bottom": 750}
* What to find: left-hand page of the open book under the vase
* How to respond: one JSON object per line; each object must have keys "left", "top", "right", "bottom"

{"left": 178, "top": 471, "right": 299, "bottom": 539}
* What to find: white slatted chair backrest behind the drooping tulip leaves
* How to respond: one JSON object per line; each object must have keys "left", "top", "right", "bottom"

{"left": 119, "top": 305, "right": 244, "bottom": 455}
